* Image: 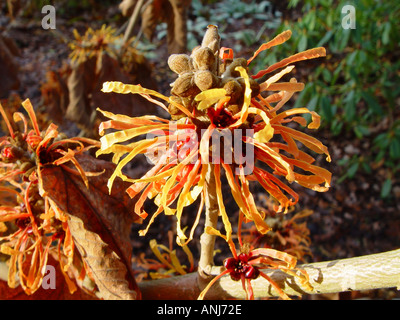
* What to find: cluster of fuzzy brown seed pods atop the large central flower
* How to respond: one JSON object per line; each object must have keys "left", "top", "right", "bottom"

{"left": 168, "top": 25, "right": 260, "bottom": 120}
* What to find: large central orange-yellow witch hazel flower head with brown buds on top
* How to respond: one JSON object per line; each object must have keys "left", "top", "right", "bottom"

{"left": 98, "top": 25, "right": 331, "bottom": 244}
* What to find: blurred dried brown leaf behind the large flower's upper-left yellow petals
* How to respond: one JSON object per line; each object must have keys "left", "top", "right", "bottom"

{"left": 65, "top": 54, "right": 157, "bottom": 136}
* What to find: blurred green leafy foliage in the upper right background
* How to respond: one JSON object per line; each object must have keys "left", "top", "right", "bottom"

{"left": 257, "top": 0, "right": 400, "bottom": 197}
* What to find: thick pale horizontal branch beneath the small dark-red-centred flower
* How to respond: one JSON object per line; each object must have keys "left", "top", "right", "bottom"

{"left": 139, "top": 249, "right": 400, "bottom": 300}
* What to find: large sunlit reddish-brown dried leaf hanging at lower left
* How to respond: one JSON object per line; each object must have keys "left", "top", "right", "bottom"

{"left": 42, "top": 155, "right": 140, "bottom": 300}
